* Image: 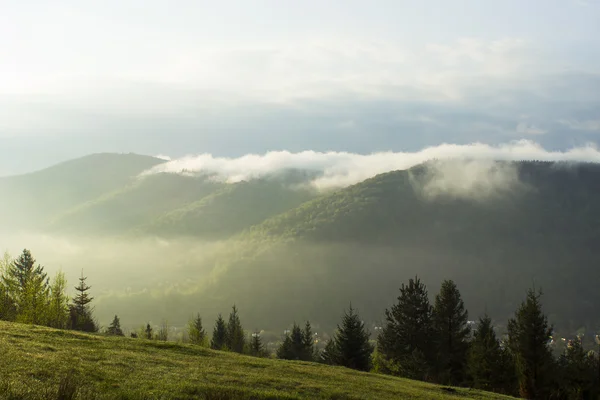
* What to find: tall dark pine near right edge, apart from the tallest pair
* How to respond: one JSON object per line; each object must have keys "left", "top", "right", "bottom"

{"left": 508, "top": 289, "right": 554, "bottom": 399}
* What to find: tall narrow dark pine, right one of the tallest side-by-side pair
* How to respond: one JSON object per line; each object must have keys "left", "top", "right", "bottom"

{"left": 433, "top": 280, "right": 471, "bottom": 386}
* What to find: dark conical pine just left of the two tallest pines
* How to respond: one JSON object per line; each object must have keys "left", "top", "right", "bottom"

{"left": 334, "top": 305, "right": 373, "bottom": 371}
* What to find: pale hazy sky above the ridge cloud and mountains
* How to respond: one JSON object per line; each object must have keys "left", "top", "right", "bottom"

{"left": 0, "top": 0, "right": 600, "bottom": 176}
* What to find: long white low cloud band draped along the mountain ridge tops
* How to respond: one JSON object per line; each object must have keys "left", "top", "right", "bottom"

{"left": 145, "top": 140, "right": 600, "bottom": 189}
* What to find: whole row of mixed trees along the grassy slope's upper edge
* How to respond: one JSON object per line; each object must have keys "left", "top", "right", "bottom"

{"left": 0, "top": 250, "right": 600, "bottom": 399}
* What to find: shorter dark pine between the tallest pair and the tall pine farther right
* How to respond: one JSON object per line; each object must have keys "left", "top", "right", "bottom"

{"left": 467, "top": 315, "right": 516, "bottom": 395}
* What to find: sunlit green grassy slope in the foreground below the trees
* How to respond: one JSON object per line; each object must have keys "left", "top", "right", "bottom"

{"left": 0, "top": 321, "right": 507, "bottom": 400}
